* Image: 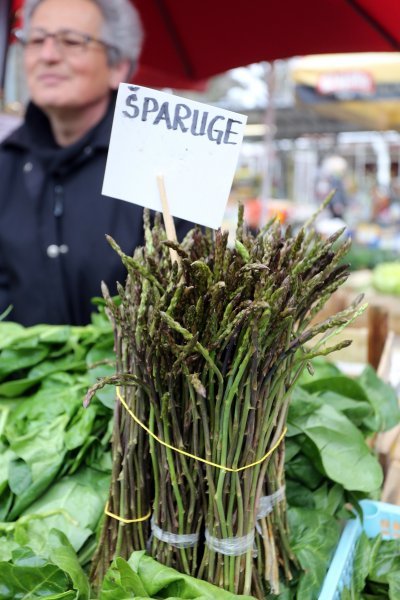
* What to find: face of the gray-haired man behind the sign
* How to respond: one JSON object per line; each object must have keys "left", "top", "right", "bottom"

{"left": 25, "top": 0, "right": 125, "bottom": 111}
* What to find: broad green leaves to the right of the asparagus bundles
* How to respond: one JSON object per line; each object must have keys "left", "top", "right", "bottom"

{"left": 284, "top": 359, "right": 400, "bottom": 600}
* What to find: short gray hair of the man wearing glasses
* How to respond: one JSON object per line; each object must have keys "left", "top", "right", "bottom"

{"left": 23, "top": 0, "right": 144, "bottom": 75}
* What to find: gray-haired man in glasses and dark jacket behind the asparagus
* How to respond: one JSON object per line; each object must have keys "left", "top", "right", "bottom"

{"left": 0, "top": 0, "right": 192, "bottom": 326}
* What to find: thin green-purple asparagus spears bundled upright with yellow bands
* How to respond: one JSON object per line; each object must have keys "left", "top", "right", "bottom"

{"left": 87, "top": 205, "right": 362, "bottom": 598}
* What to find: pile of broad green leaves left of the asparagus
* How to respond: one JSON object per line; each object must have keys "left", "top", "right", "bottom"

{"left": 0, "top": 313, "right": 115, "bottom": 568}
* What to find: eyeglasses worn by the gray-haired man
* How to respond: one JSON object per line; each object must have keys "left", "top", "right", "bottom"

{"left": 15, "top": 29, "right": 118, "bottom": 56}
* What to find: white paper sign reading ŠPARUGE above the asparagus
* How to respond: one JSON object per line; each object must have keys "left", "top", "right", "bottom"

{"left": 102, "top": 83, "right": 247, "bottom": 229}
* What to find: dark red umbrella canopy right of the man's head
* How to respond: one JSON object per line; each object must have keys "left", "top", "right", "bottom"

{"left": 132, "top": 0, "right": 400, "bottom": 88}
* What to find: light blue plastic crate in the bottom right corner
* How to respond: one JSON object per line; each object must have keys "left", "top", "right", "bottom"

{"left": 319, "top": 500, "right": 400, "bottom": 600}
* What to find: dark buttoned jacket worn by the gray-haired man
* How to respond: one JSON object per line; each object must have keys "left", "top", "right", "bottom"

{"left": 0, "top": 95, "right": 193, "bottom": 326}
